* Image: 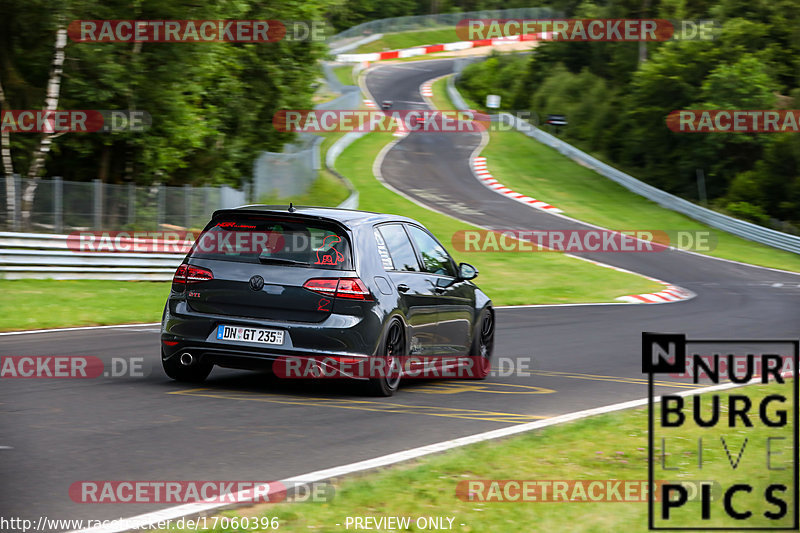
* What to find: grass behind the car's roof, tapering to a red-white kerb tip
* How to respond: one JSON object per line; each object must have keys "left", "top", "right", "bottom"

{"left": 336, "top": 133, "right": 661, "bottom": 305}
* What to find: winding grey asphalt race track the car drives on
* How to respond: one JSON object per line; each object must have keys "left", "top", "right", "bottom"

{"left": 0, "top": 60, "right": 800, "bottom": 519}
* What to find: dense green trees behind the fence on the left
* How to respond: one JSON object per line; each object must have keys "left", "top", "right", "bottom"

{"left": 0, "top": 0, "right": 331, "bottom": 186}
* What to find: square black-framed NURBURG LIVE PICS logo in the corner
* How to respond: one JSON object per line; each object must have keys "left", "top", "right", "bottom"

{"left": 642, "top": 333, "right": 800, "bottom": 531}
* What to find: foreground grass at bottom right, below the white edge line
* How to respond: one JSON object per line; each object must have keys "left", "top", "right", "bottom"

{"left": 164, "top": 385, "right": 792, "bottom": 533}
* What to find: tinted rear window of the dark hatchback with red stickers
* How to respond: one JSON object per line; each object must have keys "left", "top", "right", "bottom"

{"left": 189, "top": 217, "right": 352, "bottom": 270}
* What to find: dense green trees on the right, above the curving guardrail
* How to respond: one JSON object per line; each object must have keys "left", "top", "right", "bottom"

{"left": 459, "top": 0, "right": 800, "bottom": 230}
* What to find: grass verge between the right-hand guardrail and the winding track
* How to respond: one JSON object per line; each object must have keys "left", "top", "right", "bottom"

{"left": 433, "top": 79, "right": 800, "bottom": 271}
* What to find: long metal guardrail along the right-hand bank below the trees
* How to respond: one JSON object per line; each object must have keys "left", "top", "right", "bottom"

{"left": 447, "top": 76, "right": 800, "bottom": 254}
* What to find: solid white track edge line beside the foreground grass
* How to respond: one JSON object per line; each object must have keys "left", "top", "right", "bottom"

{"left": 64, "top": 378, "right": 788, "bottom": 533}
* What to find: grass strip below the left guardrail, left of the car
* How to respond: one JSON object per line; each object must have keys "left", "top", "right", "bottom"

{"left": 0, "top": 279, "right": 170, "bottom": 331}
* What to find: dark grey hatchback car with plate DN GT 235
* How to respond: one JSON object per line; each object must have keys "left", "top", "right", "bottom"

{"left": 161, "top": 205, "right": 494, "bottom": 396}
